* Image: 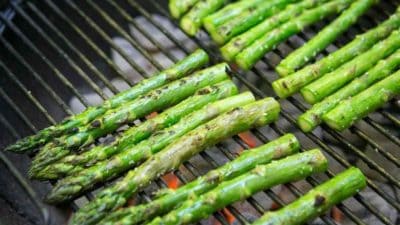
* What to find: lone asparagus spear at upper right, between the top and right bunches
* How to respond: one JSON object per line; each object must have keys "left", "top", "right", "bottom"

{"left": 276, "top": 0, "right": 377, "bottom": 76}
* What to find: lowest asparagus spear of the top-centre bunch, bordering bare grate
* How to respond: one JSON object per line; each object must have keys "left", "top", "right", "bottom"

{"left": 235, "top": 0, "right": 352, "bottom": 70}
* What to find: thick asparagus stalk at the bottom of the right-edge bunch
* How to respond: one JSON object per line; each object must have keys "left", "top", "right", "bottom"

{"left": 322, "top": 71, "right": 400, "bottom": 130}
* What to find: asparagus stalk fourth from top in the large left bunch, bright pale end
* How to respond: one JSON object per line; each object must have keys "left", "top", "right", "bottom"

{"left": 48, "top": 92, "right": 254, "bottom": 202}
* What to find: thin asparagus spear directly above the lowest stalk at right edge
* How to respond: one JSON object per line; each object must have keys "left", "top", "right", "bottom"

{"left": 297, "top": 50, "right": 400, "bottom": 132}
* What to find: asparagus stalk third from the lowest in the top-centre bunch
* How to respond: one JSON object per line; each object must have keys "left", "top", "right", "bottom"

{"left": 206, "top": 0, "right": 298, "bottom": 44}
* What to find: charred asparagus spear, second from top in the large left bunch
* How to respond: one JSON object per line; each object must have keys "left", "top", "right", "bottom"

{"left": 32, "top": 63, "right": 228, "bottom": 170}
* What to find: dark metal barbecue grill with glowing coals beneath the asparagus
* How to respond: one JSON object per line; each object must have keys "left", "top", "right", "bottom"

{"left": 0, "top": 0, "right": 400, "bottom": 225}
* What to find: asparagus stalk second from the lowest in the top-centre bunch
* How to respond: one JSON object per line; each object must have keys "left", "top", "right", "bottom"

{"left": 220, "top": 0, "right": 327, "bottom": 61}
